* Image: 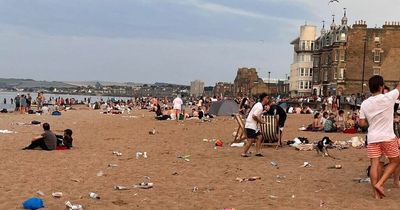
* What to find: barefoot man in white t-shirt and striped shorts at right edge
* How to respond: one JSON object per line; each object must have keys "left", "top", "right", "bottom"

{"left": 359, "top": 75, "right": 400, "bottom": 199}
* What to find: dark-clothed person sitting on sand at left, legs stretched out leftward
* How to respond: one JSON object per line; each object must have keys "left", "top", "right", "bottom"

{"left": 23, "top": 123, "right": 57, "bottom": 151}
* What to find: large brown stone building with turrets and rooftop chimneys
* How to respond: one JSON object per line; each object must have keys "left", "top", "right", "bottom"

{"left": 313, "top": 11, "right": 400, "bottom": 96}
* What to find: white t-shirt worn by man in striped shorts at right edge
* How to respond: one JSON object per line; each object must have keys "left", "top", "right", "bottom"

{"left": 360, "top": 89, "right": 399, "bottom": 143}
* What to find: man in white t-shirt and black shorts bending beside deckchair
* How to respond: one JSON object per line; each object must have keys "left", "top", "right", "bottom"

{"left": 242, "top": 93, "right": 269, "bottom": 157}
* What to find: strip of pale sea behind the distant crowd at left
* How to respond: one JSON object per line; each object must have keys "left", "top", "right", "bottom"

{"left": 0, "top": 92, "right": 131, "bottom": 111}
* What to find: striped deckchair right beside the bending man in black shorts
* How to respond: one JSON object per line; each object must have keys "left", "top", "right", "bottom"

{"left": 260, "top": 115, "right": 282, "bottom": 148}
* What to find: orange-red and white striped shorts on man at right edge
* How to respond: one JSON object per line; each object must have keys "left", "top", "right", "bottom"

{"left": 367, "top": 139, "right": 399, "bottom": 158}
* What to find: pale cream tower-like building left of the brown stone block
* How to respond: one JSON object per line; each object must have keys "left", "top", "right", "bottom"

{"left": 289, "top": 25, "right": 317, "bottom": 96}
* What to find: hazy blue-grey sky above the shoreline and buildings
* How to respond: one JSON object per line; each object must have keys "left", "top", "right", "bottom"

{"left": 0, "top": 0, "right": 400, "bottom": 85}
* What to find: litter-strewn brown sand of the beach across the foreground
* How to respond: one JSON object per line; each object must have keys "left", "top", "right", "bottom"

{"left": 0, "top": 108, "right": 400, "bottom": 210}
